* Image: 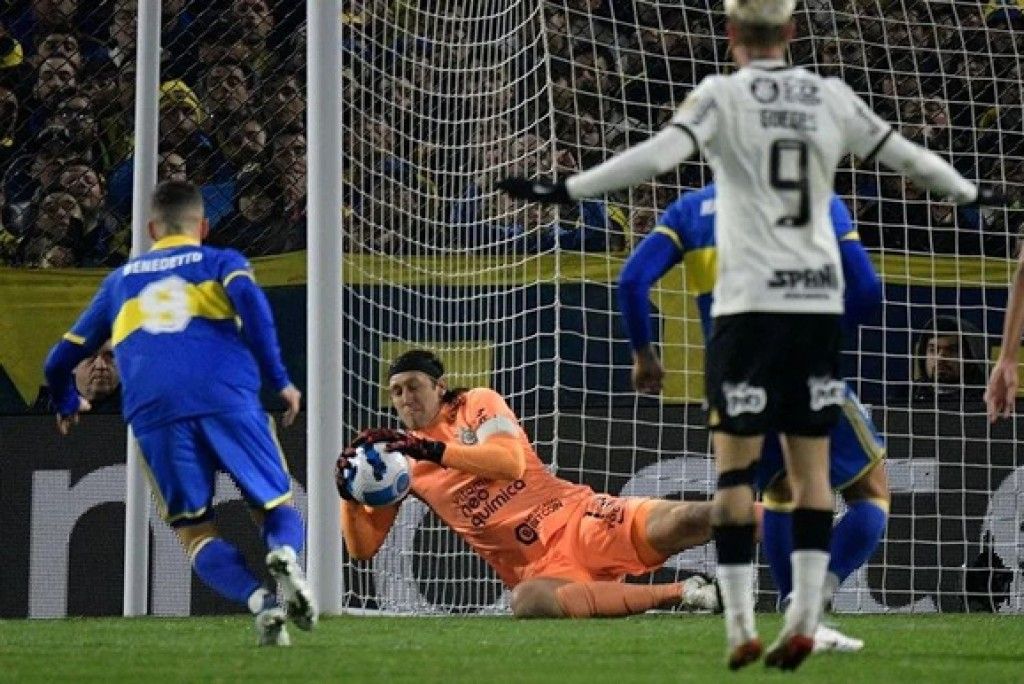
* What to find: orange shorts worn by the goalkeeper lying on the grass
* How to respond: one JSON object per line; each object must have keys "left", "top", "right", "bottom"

{"left": 522, "top": 494, "right": 667, "bottom": 582}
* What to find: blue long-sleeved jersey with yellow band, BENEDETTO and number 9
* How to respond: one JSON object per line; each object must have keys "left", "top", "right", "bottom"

{"left": 46, "top": 236, "right": 289, "bottom": 432}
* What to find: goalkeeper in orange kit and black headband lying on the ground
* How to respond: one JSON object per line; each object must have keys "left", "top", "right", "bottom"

{"left": 336, "top": 350, "right": 741, "bottom": 617}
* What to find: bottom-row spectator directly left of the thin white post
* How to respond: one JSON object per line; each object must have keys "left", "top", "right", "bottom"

{"left": 59, "top": 160, "right": 131, "bottom": 266}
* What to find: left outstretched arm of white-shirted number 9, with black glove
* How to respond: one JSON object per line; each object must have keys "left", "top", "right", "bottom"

{"left": 498, "top": 126, "right": 696, "bottom": 203}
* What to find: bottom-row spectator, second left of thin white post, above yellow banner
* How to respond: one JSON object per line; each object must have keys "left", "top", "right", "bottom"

{"left": 18, "top": 191, "right": 82, "bottom": 268}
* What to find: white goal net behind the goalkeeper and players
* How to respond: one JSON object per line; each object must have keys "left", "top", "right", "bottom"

{"left": 339, "top": 0, "right": 1024, "bottom": 612}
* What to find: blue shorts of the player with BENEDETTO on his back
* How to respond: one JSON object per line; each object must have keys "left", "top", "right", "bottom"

{"left": 135, "top": 410, "right": 292, "bottom": 525}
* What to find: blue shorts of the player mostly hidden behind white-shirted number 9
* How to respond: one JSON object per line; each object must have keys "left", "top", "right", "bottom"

{"left": 757, "top": 387, "right": 886, "bottom": 491}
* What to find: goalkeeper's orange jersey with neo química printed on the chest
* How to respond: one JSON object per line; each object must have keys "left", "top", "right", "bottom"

{"left": 412, "top": 387, "right": 594, "bottom": 587}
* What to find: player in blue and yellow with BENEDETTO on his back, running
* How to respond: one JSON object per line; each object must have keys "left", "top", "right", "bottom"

{"left": 45, "top": 182, "right": 316, "bottom": 645}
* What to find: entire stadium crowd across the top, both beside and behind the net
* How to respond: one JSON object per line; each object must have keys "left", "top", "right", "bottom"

{"left": 0, "top": 0, "right": 1024, "bottom": 267}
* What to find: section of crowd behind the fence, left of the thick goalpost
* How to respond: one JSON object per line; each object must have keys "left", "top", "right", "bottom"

{"left": 0, "top": 0, "right": 306, "bottom": 267}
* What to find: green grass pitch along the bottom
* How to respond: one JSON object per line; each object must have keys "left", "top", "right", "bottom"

{"left": 0, "top": 614, "right": 1024, "bottom": 684}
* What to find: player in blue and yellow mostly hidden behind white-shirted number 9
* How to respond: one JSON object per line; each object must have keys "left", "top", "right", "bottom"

{"left": 618, "top": 185, "right": 889, "bottom": 650}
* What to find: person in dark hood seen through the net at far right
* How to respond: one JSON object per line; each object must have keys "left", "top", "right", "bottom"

{"left": 911, "top": 315, "right": 988, "bottom": 402}
